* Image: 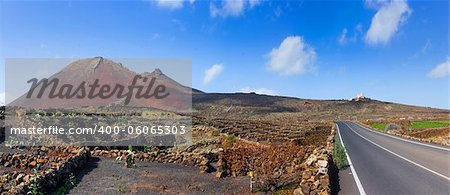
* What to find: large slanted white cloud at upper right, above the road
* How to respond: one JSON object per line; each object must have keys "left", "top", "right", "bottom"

{"left": 365, "top": 0, "right": 412, "bottom": 45}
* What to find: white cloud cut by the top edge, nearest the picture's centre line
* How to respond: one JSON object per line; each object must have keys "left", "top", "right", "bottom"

{"left": 209, "top": 0, "right": 262, "bottom": 18}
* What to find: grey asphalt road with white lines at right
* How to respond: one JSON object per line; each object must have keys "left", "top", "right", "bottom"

{"left": 337, "top": 122, "right": 450, "bottom": 195}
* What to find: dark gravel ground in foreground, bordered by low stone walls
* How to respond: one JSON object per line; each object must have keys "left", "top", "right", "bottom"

{"left": 69, "top": 157, "right": 249, "bottom": 195}
